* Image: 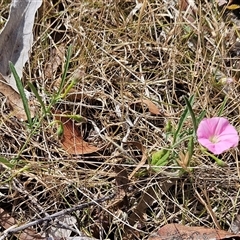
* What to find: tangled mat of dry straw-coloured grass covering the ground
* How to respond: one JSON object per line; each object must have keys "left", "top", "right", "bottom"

{"left": 0, "top": 0, "right": 240, "bottom": 239}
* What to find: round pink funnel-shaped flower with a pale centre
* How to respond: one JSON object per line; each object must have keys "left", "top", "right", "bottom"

{"left": 197, "top": 117, "right": 239, "bottom": 154}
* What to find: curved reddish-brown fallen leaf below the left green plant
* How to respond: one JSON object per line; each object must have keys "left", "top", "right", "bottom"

{"left": 55, "top": 116, "right": 99, "bottom": 154}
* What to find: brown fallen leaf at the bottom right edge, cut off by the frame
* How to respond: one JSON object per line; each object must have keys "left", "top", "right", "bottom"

{"left": 148, "top": 223, "right": 240, "bottom": 240}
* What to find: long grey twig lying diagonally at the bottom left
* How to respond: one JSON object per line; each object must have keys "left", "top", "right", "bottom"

{"left": 0, "top": 193, "right": 115, "bottom": 240}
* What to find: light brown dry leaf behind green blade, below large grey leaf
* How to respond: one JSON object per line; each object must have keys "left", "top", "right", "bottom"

{"left": 0, "top": 74, "right": 34, "bottom": 121}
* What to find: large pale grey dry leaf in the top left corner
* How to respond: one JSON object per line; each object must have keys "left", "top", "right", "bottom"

{"left": 0, "top": 0, "right": 42, "bottom": 94}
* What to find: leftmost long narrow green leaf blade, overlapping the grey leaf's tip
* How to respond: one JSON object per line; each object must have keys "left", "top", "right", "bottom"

{"left": 9, "top": 62, "right": 32, "bottom": 128}
